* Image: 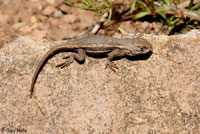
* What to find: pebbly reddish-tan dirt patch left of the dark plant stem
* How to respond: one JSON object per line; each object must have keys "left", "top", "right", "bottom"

{"left": 0, "top": 0, "right": 96, "bottom": 46}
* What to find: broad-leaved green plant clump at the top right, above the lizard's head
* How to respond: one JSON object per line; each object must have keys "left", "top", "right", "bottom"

{"left": 131, "top": 0, "right": 200, "bottom": 34}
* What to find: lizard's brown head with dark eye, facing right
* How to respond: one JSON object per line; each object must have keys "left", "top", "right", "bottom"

{"left": 126, "top": 38, "right": 152, "bottom": 56}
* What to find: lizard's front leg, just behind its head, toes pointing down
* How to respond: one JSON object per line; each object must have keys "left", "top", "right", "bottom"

{"left": 106, "top": 49, "right": 126, "bottom": 72}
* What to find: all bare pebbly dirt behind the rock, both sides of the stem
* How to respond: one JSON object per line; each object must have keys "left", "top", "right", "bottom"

{"left": 0, "top": 0, "right": 198, "bottom": 48}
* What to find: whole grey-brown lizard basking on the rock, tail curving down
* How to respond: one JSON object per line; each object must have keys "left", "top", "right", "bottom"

{"left": 30, "top": 35, "right": 152, "bottom": 98}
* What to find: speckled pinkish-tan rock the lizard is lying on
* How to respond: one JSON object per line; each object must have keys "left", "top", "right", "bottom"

{"left": 0, "top": 31, "right": 200, "bottom": 134}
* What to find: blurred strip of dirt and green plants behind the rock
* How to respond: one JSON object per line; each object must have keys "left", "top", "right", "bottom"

{"left": 0, "top": 0, "right": 200, "bottom": 47}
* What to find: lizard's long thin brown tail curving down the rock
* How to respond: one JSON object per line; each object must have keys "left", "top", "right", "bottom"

{"left": 30, "top": 44, "right": 74, "bottom": 98}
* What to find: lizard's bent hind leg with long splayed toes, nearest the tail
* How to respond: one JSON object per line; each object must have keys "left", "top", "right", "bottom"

{"left": 56, "top": 49, "right": 85, "bottom": 68}
